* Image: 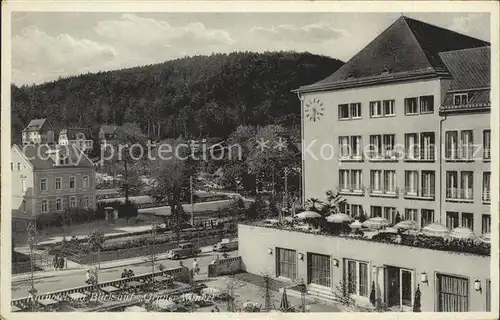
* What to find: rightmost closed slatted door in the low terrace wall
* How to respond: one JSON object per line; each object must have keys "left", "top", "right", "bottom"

{"left": 437, "top": 274, "right": 469, "bottom": 312}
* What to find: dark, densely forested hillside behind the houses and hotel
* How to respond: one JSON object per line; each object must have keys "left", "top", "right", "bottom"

{"left": 12, "top": 52, "right": 342, "bottom": 142}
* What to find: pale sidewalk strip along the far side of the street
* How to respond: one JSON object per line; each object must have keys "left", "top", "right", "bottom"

{"left": 11, "top": 246, "right": 212, "bottom": 283}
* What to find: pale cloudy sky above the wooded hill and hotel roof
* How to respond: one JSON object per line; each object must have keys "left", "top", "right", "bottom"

{"left": 11, "top": 12, "right": 490, "bottom": 85}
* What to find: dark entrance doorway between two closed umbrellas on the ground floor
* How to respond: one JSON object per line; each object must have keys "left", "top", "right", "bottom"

{"left": 386, "top": 266, "right": 413, "bottom": 307}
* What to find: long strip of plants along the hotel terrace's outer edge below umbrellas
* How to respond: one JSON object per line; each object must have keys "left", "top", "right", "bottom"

{"left": 245, "top": 221, "right": 491, "bottom": 256}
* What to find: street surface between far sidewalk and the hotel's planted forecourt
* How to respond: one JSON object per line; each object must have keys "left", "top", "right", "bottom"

{"left": 12, "top": 251, "right": 238, "bottom": 299}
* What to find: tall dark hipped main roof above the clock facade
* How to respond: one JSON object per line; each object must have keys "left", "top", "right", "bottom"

{"left": 298, "top": 16, "right": 490, "bottom": 92}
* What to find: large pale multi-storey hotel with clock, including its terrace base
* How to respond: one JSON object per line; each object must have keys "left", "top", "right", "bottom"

{"left": 239, "top": 16, "right": 491, "bottom": 311}
